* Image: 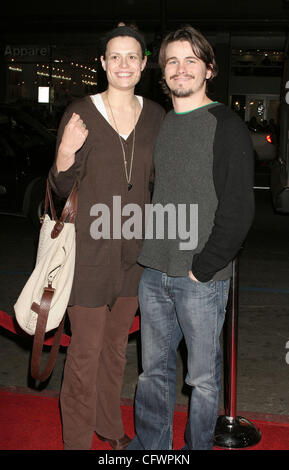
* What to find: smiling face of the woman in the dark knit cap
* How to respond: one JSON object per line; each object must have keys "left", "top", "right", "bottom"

{"left": 101, "top": 36, "right": 147, "bottom": 90}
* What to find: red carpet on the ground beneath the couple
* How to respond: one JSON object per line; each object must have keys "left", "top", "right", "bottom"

{"left": 0, "top": 389, "right": 289, "bottom": 450}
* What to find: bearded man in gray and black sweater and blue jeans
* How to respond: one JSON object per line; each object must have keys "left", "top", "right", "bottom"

{"left": 127, "top": 26, "right": 254, "bottom": 450}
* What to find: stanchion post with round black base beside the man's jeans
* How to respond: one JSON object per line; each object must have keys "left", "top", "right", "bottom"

{"left": 214, "top": 256, "right": 261, "bottom": 449}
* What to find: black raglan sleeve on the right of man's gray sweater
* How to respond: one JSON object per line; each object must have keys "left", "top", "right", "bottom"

{"left": 192, "top": 110, "right": 255, "bottom": 282}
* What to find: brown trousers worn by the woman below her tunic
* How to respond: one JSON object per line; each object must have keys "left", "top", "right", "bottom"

{"left": 60, "top": 297, "right": 138, "bottom": 450}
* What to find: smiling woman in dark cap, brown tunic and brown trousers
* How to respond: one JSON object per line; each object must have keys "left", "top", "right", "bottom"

{"left": 50, "top": 26, "right": 164, "bottom": 450}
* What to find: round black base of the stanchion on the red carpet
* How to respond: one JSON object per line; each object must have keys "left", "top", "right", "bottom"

{"left": 214, "top": 416, "right": 262, "bottom": 449}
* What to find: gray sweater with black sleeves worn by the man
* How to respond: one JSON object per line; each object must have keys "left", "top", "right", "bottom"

{"left": 138, "top": 103, "right": 254, "bottom": 282}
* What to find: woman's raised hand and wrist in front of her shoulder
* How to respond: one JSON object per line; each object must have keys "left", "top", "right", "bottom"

{"left": 56, "top": 113, "right": 88, "bottom": 171}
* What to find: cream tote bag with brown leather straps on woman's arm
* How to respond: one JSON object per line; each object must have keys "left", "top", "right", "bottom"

{"left": 14, "top": 180, "right": 77, "bottom": 381}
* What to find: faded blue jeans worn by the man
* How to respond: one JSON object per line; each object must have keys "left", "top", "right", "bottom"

{"left": 127, "top": 268, "right": 230, "bottom": 450}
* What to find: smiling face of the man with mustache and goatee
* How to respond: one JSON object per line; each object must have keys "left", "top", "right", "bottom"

{"left": 164, "top": 41, "right": 212, "bottom": 98}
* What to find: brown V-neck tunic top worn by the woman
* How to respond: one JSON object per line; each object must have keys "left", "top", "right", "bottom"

{"left": 49, "top": 96, "right": 165, "bottom": 307}
